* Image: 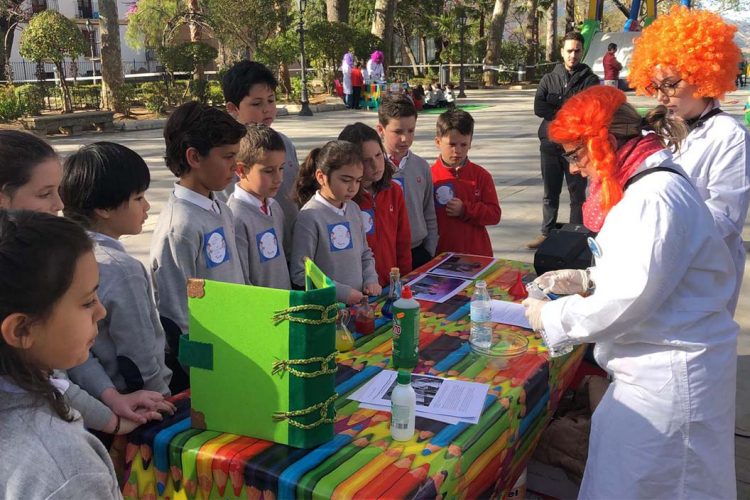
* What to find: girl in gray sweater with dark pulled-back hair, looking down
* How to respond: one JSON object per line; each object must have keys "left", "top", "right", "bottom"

{"left": 291, "top": 141, "right": 382, "bottom": 304}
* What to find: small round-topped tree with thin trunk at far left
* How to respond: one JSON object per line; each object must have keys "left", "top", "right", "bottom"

{"left": 20, "top": 10, "right": 86, "bottom": 113}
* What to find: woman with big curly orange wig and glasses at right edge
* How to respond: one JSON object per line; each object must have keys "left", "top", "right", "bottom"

{"left": 629, "top": 7, "right": 750, "bottom": 313}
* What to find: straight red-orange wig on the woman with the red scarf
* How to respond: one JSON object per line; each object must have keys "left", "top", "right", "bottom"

{"left": 549, "top": 85, "right": 626, "bottom": 214}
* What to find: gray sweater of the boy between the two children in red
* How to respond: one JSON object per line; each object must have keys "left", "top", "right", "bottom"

{"left": 393, "top": 151, "right": 438, "bottom": 255}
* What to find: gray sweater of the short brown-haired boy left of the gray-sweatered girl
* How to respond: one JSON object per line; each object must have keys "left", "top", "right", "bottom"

{"left": 228, "top": 194, "right": 291, "bottom": 290}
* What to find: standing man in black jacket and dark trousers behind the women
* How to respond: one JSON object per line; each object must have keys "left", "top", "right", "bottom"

{"left": 526, "top": 32, "right": 599, "bottom": 248}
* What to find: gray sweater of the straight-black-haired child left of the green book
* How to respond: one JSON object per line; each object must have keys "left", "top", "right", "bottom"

{"left": 68, "top": 233, "right": 172, "bottom": 397}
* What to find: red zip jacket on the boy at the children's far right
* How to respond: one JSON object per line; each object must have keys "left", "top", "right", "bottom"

{"left": 432, "top": 157, "right": 500, "bottom": 257}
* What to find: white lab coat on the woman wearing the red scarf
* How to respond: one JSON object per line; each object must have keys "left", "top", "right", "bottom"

{"left": 541, "top": 150, "right": 739, "bottom": 500}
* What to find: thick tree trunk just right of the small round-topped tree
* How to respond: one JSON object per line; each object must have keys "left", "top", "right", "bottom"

{"left": 98, "top": 0, "right": 128, "bottom": 113}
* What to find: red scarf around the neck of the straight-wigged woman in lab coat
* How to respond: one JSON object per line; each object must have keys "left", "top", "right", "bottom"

{"left": 583, "top": 134, "right": 664, "bottom": 233}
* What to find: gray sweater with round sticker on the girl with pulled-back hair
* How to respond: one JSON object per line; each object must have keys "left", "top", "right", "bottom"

{"left": 291, "top": 198, "right": 378, "bottom": 302}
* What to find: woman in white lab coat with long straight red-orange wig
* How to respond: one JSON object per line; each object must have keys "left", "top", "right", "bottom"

{"left": 524, "top": 86, "right": 738, "bottom": 499}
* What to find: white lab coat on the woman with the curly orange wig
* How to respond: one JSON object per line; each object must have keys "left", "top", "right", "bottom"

{"left": 675, "top": 101, "right": 750, "bottom": 314}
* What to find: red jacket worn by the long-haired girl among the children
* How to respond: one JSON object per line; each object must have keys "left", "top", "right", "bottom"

{"left": 358, "top": 181, "right": 411, "bottom": 286}
